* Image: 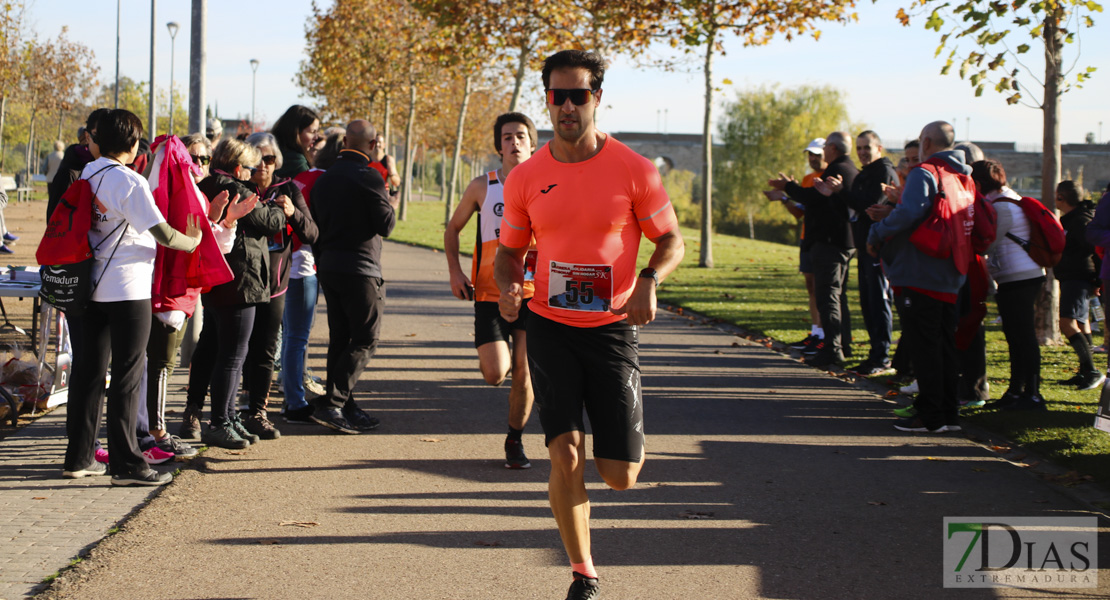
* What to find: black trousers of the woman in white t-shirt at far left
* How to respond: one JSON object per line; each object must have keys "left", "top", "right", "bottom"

{"left": 64, "top": 298, "right": 151, "bottom": 475}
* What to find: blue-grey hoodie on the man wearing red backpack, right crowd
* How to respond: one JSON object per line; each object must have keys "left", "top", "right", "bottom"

{"left": 867, "top": 150, "right": 971, "bottom": 294}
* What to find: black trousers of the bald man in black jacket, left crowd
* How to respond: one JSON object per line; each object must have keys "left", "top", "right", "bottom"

{"left": 316, "top": 272, "right": 385, "bottom": 408}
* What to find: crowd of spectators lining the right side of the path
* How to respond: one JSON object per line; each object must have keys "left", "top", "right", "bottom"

{"left": 765, "top": 121, "right": 1110, "bottom": 433}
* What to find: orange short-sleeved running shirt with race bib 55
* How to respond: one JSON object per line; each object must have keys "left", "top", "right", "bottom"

{"left": 501, "top": 135, "right": 678, "bottom": 327}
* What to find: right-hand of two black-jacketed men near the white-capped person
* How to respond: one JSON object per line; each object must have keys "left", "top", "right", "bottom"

{"left": 848, "top": 130, "right": 898, "bottom": 377}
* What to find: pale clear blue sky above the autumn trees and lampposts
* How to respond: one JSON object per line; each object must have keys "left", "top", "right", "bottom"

{"left": 29, "top": 0, "right": 1110, "bottom": 145}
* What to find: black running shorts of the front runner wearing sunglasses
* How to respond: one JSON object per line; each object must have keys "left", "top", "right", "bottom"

{"left": 527, "top": 314, "right": 644, "bottom": 462}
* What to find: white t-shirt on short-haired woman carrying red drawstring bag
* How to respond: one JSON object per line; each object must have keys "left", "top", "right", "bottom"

{"left": 81, "top": 156, "right": 165, "bottom": 302}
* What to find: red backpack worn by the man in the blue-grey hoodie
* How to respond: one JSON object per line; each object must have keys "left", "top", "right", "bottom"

{"left": 909, "top": 157, "right": 993, "bottom": 274}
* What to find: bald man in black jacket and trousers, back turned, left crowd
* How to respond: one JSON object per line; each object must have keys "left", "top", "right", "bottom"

{"left": 311, "top": 120, "right": 397, "bottom": 434}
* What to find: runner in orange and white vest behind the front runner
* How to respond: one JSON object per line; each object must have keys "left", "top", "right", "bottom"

{"left": 443, "top": 112, "right": 536, "bottom": 469}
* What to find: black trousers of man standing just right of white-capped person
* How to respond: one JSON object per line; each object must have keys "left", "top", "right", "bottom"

{"left": 810, "top": 242, "right": 856, "bottom": 354}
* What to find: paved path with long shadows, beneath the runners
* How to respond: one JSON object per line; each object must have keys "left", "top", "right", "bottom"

{"left": 0, "top": 239, "right": 1110, "bottom": 599}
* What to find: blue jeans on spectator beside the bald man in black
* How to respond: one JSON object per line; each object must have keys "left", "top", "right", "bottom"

{"left": 281, "top": 275, "right": 320, "bottom": 409}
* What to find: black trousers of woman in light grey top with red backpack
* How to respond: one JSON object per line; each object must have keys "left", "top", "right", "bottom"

{"left": 995, "top": 277, "right": 1045, "bottom": 395}
